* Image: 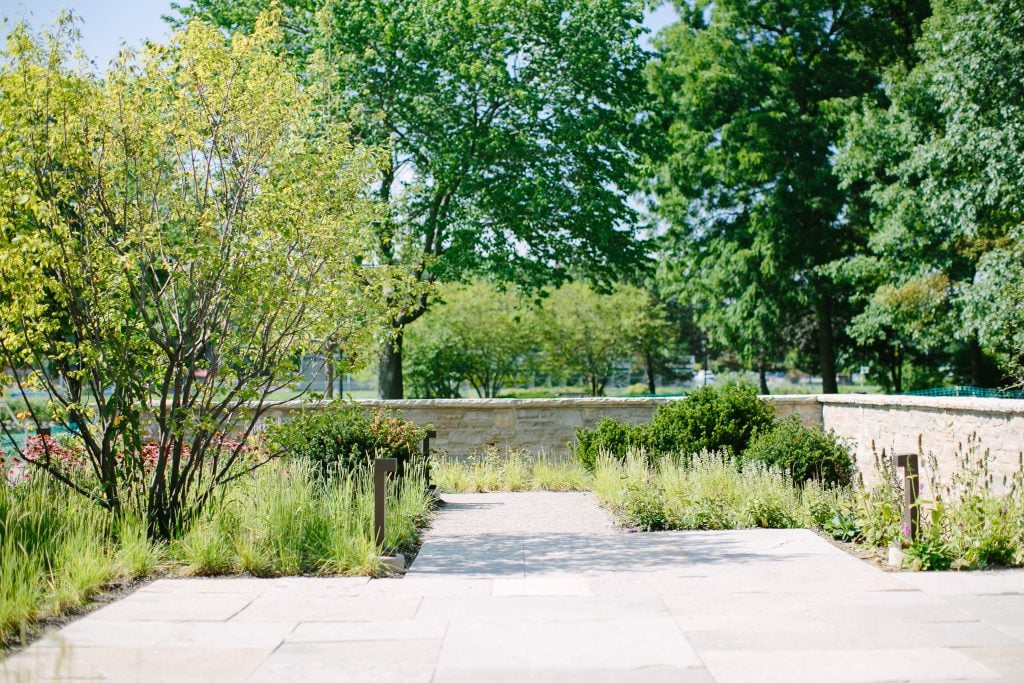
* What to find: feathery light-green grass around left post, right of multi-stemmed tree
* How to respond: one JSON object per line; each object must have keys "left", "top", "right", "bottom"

{"left": 172, "top": 460, "right": 431, "bottom": 575}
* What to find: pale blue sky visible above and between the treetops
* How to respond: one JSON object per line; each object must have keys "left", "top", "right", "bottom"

{"left": 0, "top": 0, "right": 675, "bottom": 67}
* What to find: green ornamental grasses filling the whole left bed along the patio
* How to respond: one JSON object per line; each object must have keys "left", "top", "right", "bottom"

{"left": 0, "top": 460, "right": 431, "bottom": 644}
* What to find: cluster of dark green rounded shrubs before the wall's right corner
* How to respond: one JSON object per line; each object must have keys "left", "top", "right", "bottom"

{"left": 573, "top": 386, "right": 854, "bottom": 484}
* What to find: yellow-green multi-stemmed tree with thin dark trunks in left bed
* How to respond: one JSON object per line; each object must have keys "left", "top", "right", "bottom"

{"left": 0, "top": 9, "right": 400, "bottom": 538}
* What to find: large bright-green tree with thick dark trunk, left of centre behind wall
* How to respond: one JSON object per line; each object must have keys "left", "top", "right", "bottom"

{"left": 178, "top": 0, "right": 646, "bottom": 398}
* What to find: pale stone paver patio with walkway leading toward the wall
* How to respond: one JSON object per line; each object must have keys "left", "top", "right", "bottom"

{"left": 0, "top": 494, "right": 1024, "bottom": 683}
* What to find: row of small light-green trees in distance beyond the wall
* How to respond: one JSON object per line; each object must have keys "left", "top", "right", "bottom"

{"left": 406, "top": 281, "right": 691, "bottom": 398}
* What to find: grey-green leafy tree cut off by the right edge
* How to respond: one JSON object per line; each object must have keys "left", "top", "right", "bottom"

{"left": 840, "top": 0, "right": 1024, "bottom": 386}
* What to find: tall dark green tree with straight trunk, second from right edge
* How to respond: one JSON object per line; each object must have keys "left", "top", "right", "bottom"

{"left": 651, "top": 0, "right": 928, "bottom": 392}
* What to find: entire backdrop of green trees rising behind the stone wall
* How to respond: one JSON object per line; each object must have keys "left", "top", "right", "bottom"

{"left": 177, "top": 0, "right": 1024, "bottom": 398}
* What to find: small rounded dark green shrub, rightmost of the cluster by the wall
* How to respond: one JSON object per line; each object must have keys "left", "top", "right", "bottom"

{"left": 742, "top": 415, "right": 854, "bottom": 485}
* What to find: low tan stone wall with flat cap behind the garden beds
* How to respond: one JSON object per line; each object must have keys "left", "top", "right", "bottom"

{"left": 260, "top": 394, "right": 1024, "bottom": 491}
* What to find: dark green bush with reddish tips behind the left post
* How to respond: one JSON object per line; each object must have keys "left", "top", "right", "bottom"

{"left": 266, "top": 401, "right": 427, "bottom": 477}
